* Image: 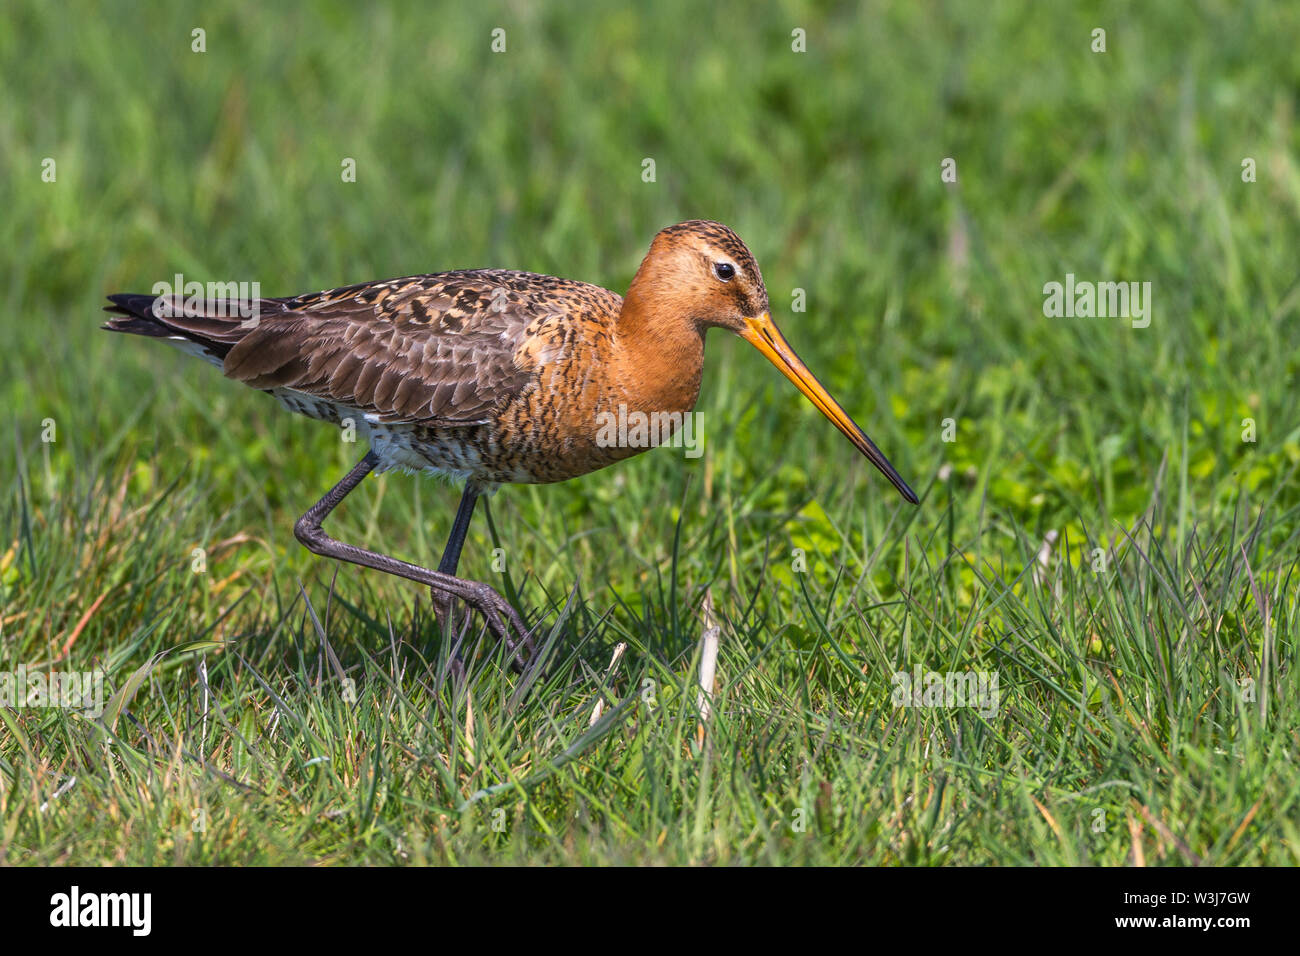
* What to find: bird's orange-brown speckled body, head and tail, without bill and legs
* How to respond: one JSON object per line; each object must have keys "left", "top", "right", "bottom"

{"left": 107, "top": 221, "right": 767, "bottom": 485}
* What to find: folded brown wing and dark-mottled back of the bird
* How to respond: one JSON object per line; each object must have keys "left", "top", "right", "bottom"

{"left": 110, "top": 269, "right": 621, "bottom": 425}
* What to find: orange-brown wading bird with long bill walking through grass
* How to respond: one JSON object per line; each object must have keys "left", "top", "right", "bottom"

{"left": 103, "top": 220, "right": 918, "bottom": 669}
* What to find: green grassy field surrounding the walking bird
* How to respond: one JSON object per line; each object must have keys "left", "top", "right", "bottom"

{"left": 0, "top": 0, "right": 1300, "bottom": 866}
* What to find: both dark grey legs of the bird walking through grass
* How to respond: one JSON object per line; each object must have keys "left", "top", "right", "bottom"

{"left": 294, "top": 451, "right": 533, "bottom": 667}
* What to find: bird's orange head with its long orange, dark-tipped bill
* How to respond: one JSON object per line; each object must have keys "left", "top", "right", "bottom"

{"left": 629, "top": 220, "right": 917, "bottom": 505}
